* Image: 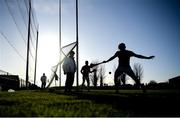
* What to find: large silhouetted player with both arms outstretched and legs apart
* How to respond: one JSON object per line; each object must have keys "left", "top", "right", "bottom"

{"left": 103, "top": 43, "right": 155, "bottom": 92}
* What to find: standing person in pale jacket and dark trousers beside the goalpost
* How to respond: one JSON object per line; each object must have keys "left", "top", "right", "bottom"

{"left": 63, "top": 51, "right": 77, "bottom": 92}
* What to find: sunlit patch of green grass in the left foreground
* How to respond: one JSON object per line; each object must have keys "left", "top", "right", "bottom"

{"left": 0, "top": 91, "right": 124, "bottom": 117}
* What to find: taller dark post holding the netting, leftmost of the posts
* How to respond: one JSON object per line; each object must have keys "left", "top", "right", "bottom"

{"left": 26, "top": 0, "right": 31, "bottom": 88}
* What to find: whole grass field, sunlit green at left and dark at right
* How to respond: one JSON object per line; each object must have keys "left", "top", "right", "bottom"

{"left": 0, "top": 89, "right": 180, "bottom": 117}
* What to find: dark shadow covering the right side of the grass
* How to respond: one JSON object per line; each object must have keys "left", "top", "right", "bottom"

{"left": 53, "top": 90, "right": 180, "bottom": 117}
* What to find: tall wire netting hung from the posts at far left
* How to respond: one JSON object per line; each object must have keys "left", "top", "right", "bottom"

{"left": 0, "top": 0, "right": 38, "bottom": 86}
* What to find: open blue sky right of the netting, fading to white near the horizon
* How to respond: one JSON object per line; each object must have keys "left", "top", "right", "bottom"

{"left": 0, "top": 0, "right": 180, "bottom": 85}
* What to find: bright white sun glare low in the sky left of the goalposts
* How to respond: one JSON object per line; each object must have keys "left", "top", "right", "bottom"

{"left": 37, "top": 32, "right": 59, "bottom": 85}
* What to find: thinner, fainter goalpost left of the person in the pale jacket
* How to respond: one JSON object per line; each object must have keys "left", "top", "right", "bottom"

{"left": 59, "top": 0, "right": 61, "bottom": 86}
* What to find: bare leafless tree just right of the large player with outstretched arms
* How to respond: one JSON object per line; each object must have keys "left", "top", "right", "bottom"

{"left": 133, "top": 63, "right": 143, "bottom": 82}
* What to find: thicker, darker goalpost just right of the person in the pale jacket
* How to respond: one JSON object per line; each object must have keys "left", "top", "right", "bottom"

{"left": 76, "top": 0, "right": 79, "bottom": 87}
